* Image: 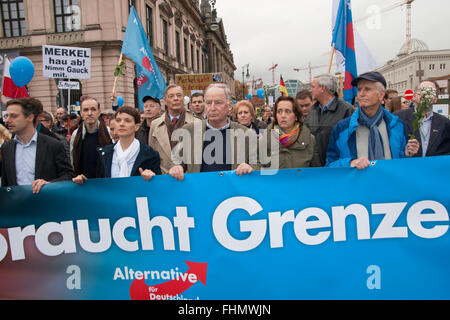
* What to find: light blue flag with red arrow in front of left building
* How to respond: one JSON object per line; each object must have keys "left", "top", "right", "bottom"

{"left": 122, "top": 7, "right": 167, "bottom": 110}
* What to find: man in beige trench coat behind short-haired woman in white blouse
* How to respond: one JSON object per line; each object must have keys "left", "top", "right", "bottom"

{"left": 148, "top": 85, "right": 201, "bottom": 174}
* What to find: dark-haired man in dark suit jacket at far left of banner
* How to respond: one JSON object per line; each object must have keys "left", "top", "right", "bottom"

{"left": 1, "top": 98, "right": 74, "bottom": 193}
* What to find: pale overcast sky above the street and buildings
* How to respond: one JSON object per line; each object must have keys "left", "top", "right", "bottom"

{"left": 216, "top": 0, "right": 450, "bottom": 85}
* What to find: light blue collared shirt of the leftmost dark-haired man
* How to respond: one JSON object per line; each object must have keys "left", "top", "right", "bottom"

{"left": 14, "top": 130, "right": 38, "bottom": 186}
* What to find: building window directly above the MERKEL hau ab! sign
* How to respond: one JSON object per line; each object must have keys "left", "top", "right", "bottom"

{"left": 53, "top": 0, "right": 80, "bottom": 32}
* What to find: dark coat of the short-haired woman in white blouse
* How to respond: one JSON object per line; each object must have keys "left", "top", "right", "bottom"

{"left": 97, "top": 142, "right": 161, "bottom": 178}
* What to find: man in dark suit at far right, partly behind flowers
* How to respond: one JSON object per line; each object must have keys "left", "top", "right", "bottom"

{"left": 395, "top": 80, "right": 450, "bottom": 157}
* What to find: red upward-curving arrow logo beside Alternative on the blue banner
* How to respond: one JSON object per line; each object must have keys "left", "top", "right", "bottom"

{"left": 130, "top": 261, "right": 208, "bottom": 300}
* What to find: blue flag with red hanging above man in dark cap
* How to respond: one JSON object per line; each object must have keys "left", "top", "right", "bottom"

{"left": 332, "top": 0, "right": 358, "bottom": 104}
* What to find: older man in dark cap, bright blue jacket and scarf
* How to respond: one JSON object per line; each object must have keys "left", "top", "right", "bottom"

{"left": 326, "top": 72, "right": 420, "bottom": 170}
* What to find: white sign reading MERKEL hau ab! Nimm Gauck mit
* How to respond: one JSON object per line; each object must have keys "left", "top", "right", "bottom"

{"left": 42, "top": 46, "right": 91, "bottom": 79}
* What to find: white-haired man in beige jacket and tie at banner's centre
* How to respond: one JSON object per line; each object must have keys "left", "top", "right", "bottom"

{"left": 169, "top": 84, "right": 259, "bottom": 181}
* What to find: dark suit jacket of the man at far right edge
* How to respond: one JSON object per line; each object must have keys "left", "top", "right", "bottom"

{"left": 395, "top": 109, "right": 450, "bottom": 157}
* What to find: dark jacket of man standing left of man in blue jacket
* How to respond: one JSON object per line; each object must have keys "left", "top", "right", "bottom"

{"left": 305, "top": 98, "right": 355, "bottom": 167}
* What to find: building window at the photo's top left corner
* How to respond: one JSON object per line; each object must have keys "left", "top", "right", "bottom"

{"left": 0, "top": 0, "right": 27, "bottom": 38}
